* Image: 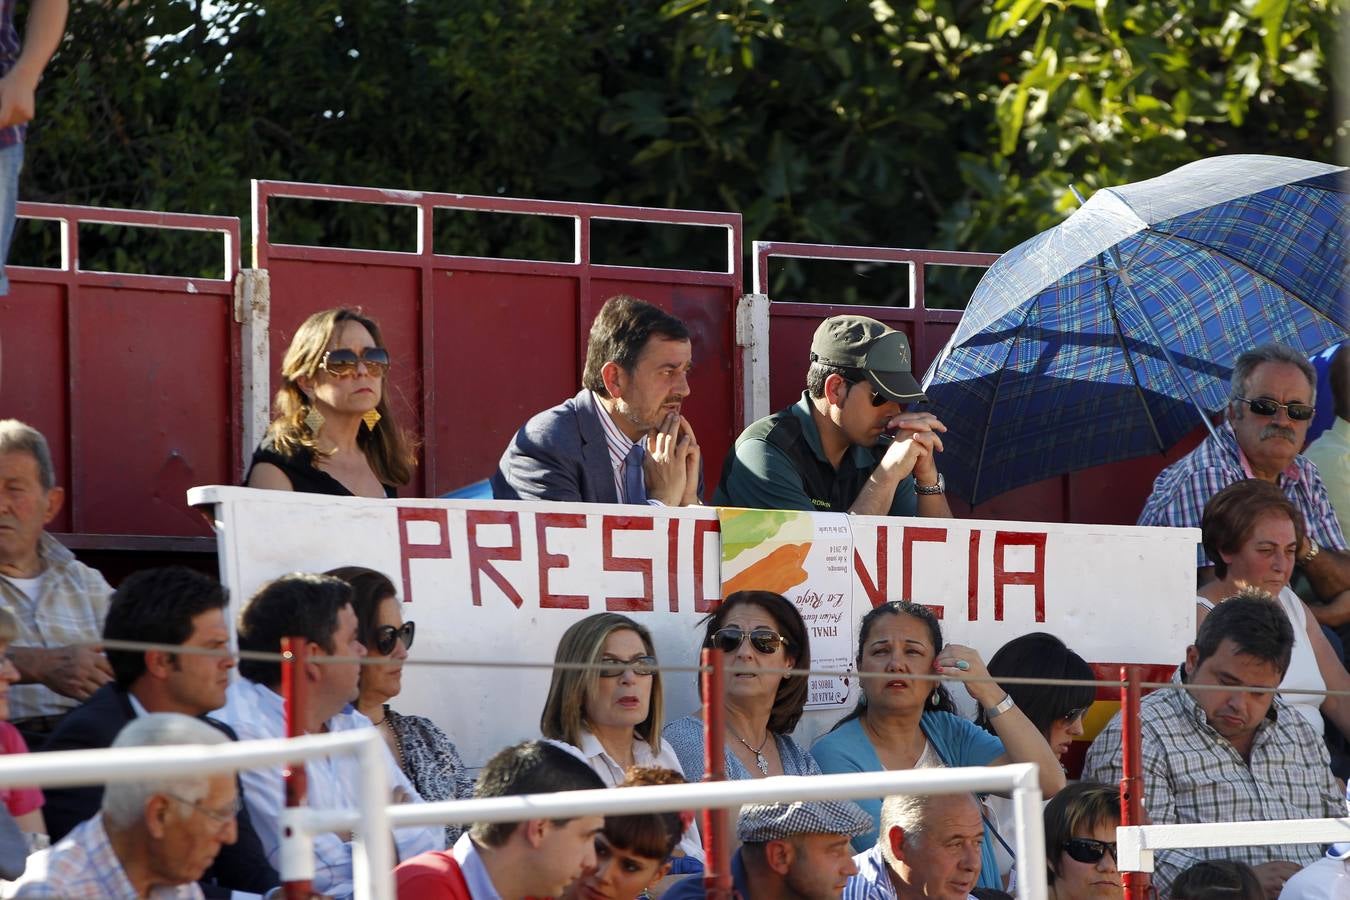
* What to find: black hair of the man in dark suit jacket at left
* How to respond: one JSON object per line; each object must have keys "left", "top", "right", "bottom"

{"left": 103, "top": 565, "right": 228, "bottom": 691}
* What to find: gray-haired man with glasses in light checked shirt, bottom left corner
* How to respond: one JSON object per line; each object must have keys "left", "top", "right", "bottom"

{"left": 12, "top": 712, "right": 239, "bottom": 900}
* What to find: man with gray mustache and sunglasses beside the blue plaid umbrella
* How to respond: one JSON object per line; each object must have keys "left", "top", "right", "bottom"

{"left": 1139, "top": 343, "right": 1350, "bottom": 627}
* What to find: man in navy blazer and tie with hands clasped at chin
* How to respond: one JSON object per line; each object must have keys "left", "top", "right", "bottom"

{"left": 491, "top": 294, "right": 703, "bottom": 506}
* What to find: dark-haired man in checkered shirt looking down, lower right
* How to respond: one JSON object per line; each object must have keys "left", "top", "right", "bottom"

{"left": 1083, "top": 594, "right": 1346, "bottom": 900}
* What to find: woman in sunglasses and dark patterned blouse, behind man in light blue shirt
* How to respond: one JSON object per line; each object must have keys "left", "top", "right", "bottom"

{"left": 325, "top": 565, "right": 474, "bottom": 846}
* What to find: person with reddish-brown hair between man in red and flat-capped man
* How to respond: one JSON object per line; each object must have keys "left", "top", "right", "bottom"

{"left": 562, "top": 766, "right": 694, "bottom": 900}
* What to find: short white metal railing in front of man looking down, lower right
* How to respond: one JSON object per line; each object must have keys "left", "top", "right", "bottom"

{"left": 1115, "top": 818, "right": 1350, "bottom": 872}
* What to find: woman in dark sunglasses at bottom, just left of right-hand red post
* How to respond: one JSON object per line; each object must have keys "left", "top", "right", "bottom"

{"left": 1045, "top": 781, "right": 1125, "bottom": 900}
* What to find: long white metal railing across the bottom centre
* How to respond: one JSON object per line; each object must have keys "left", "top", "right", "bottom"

{"left": 301, "top": 762, "right": 1046, "bottom": 900}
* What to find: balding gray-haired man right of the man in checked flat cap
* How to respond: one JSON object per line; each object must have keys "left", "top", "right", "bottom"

{"left": 842, "top": 793, "right": 984, "bottom": 900}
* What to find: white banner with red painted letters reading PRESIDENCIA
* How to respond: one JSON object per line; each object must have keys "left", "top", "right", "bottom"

{"left": 188, "top": 486, "right": 1199, "bottom": 766}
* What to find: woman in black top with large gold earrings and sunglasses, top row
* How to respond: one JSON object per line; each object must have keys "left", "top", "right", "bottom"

{"left": 244, "top": 308, "right": 413, "bottom": 497}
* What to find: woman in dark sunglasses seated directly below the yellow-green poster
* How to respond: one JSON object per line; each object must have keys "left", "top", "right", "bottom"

{"left": 666, "top": 591, "right": 821, "bottom": 781}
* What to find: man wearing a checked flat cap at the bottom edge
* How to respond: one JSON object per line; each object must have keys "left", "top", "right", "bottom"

{"left": 666, "top": 800, "right": 872, "bottom": 900}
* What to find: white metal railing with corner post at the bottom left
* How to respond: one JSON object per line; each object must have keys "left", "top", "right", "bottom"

{"left": 0, "top": 729, "right": 394, "bottom": 900}
